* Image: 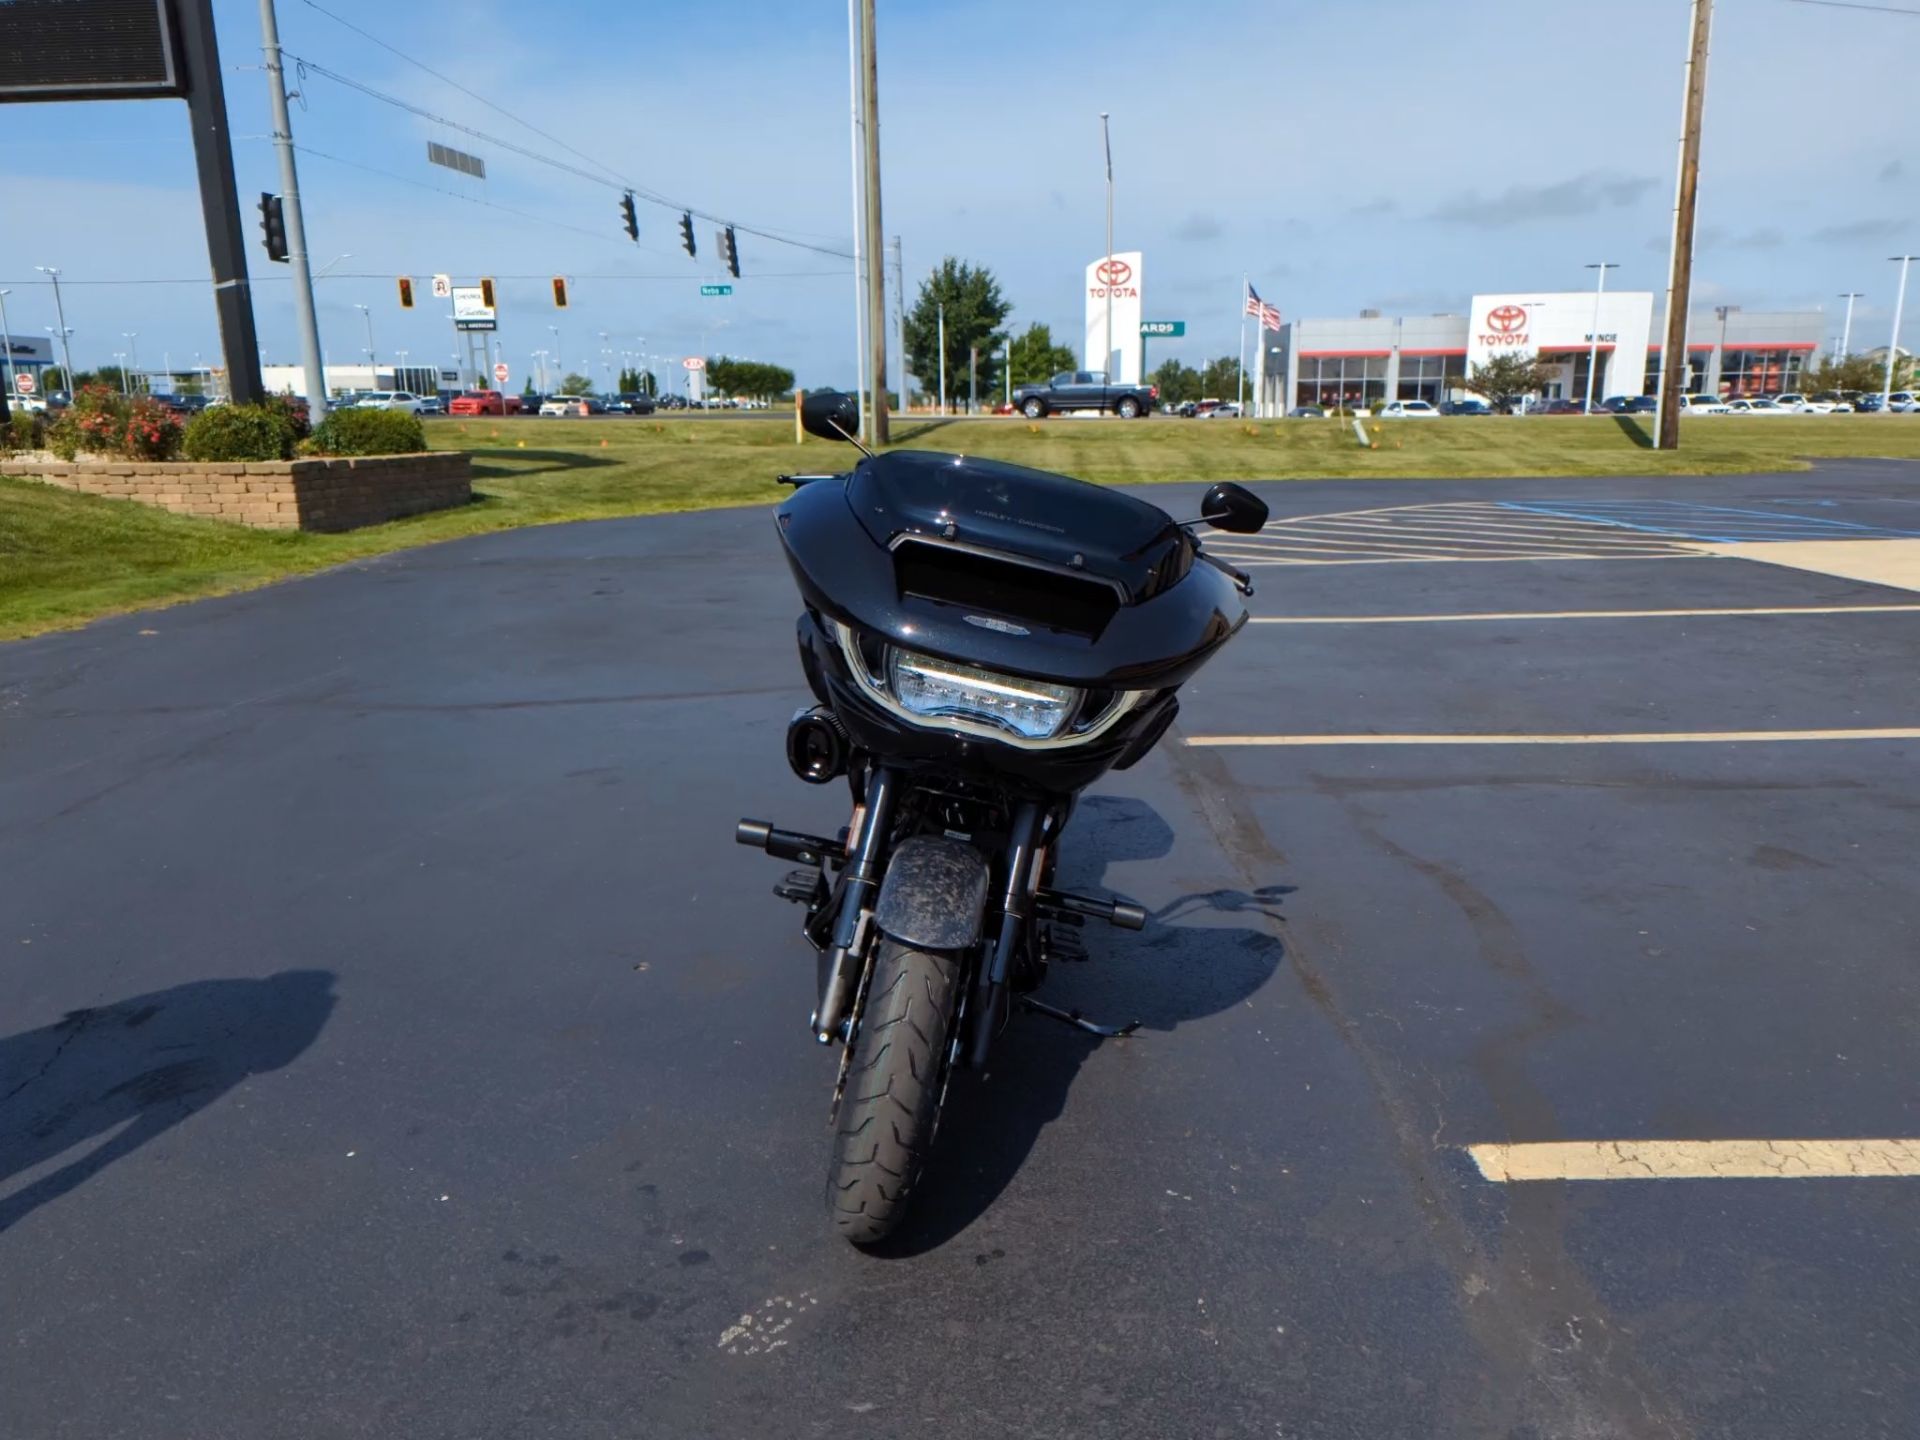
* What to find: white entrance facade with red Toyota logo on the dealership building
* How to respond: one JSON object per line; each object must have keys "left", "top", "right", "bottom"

{"left": 1467, "top": 290, "right": 1653, "bottom": 397}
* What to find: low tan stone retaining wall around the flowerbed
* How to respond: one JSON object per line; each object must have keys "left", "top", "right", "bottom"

{"left": 0, "top": 451, "right": 472, "bottom": 530}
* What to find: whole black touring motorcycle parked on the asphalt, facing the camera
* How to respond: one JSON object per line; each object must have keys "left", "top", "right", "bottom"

{"left": 735, "top": 392, "right": 1267, "bottom": 1244}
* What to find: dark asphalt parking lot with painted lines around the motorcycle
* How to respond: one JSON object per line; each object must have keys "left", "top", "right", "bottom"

{"left": 0, "top": 463, "right": 1920, "bottom": 1440}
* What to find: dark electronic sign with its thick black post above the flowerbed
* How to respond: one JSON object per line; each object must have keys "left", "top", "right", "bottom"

{"left": 0, "top": 0, "right": 265, "bottom": 403}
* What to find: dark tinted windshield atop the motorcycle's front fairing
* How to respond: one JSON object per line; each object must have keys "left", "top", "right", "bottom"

{"left": 847, "top": 449, "right": 1192, "bottom": 603}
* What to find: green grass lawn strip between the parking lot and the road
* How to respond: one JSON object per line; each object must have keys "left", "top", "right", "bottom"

{"left": 0, "top": 415, "right": 1920, "bottom": 639}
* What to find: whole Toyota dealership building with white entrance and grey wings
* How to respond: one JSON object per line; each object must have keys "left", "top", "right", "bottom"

{"left": 1263, "top": 290, "right": 1826, "bottom": 415}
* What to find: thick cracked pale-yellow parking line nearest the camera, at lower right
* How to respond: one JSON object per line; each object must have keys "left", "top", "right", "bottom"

{"left": 1467, "top": 1140, "right": 1920, "bottom": 1185}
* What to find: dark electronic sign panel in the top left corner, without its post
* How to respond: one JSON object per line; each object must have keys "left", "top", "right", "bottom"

{"left": 0, "top": 0, "right": 186, "bottom": 100}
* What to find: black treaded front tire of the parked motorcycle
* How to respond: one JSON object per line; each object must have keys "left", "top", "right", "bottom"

{"left": 828, "top": 939, "right": 964, "bottom": 1244}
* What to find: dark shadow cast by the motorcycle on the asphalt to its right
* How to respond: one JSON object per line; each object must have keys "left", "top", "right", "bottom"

{"left": 868, "top": 795, "right": 1294, "bottom": 1260}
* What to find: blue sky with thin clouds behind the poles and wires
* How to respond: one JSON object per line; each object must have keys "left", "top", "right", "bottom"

{"left": 0, "top": 0, "right": 1920, "bottom": 386}
